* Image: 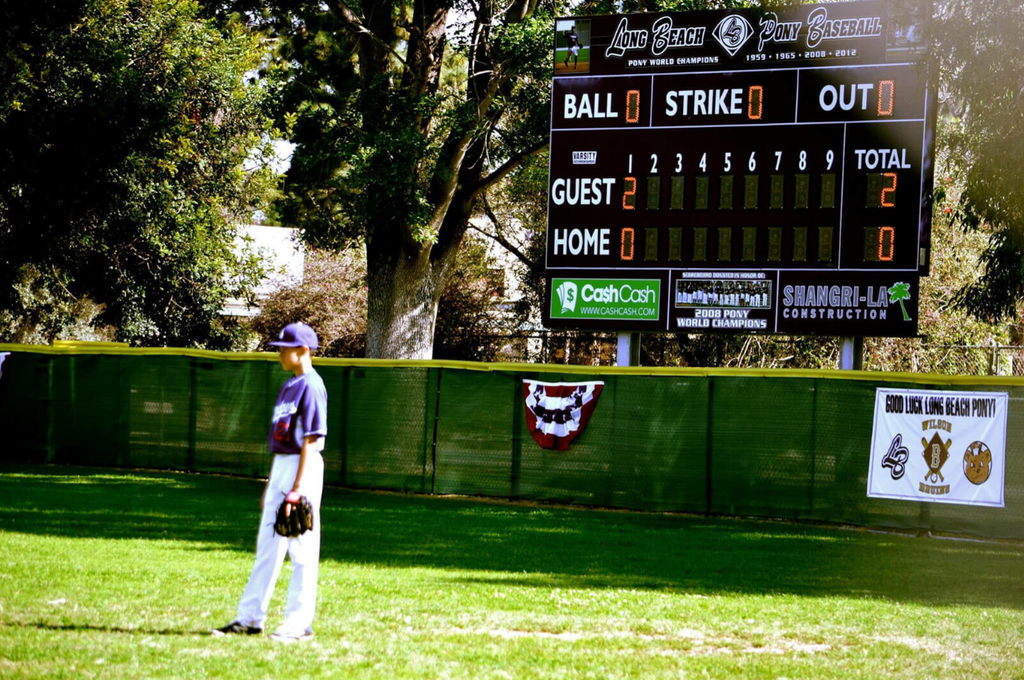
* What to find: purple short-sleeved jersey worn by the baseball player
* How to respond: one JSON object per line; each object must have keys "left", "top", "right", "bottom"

{"left": 267, "top": 371, "right": 327, "bottom": 454}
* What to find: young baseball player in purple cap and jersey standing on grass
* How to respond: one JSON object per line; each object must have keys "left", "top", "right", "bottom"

{"left": 213, "top": 324, "right": 327, "bottom": 642}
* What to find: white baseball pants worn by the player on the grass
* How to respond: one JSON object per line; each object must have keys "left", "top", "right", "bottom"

{"left": 236, "top": 452, "right": 324, "bottom": 634}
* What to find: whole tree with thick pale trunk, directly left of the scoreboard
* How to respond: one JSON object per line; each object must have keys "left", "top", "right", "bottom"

{"left": 222, "top": 0, "right": 551, "bottom": 358}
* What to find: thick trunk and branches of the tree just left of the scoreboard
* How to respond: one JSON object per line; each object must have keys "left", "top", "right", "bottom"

{"left": 323, "top": 0, "right": 538, "bottom": 359}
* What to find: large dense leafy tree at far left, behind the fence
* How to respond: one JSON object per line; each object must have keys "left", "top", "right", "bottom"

{"left": 0, "top": 0, "right": 271, "bottom": 347}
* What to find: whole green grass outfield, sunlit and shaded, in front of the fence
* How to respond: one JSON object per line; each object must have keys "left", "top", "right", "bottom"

{"left": 0, "top": 466, "right": 1024, "bottom": 680}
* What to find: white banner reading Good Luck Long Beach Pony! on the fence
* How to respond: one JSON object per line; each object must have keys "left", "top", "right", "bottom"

{"left": 867, "top": 388, "right": 1009, "bottom": 508}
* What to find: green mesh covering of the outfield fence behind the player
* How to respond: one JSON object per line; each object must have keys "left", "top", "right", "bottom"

{"left": 0, "top": 346, "right": 1024, "bottom": 539}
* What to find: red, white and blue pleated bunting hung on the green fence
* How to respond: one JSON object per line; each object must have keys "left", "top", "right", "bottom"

{"left": 522, "top": 380, "right": 604, "bottom": 451}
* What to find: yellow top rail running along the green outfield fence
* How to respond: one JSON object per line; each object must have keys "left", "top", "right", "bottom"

{"left": 0, "top": 341, "right": 1024, "bottom": 387}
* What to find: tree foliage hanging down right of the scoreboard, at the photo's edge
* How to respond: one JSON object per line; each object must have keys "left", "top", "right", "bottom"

{"left": 926, "top": 0, "right": 1024, "bottom": 321}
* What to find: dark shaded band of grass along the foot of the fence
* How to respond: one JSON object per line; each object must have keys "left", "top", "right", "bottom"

{"left": 6, "top": 466, "right": 1024, "bottom": 610}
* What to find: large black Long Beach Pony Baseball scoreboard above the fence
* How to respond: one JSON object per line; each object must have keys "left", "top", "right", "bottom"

{"left": 544, "top": 2, "right": 936, "bottom": 337}
